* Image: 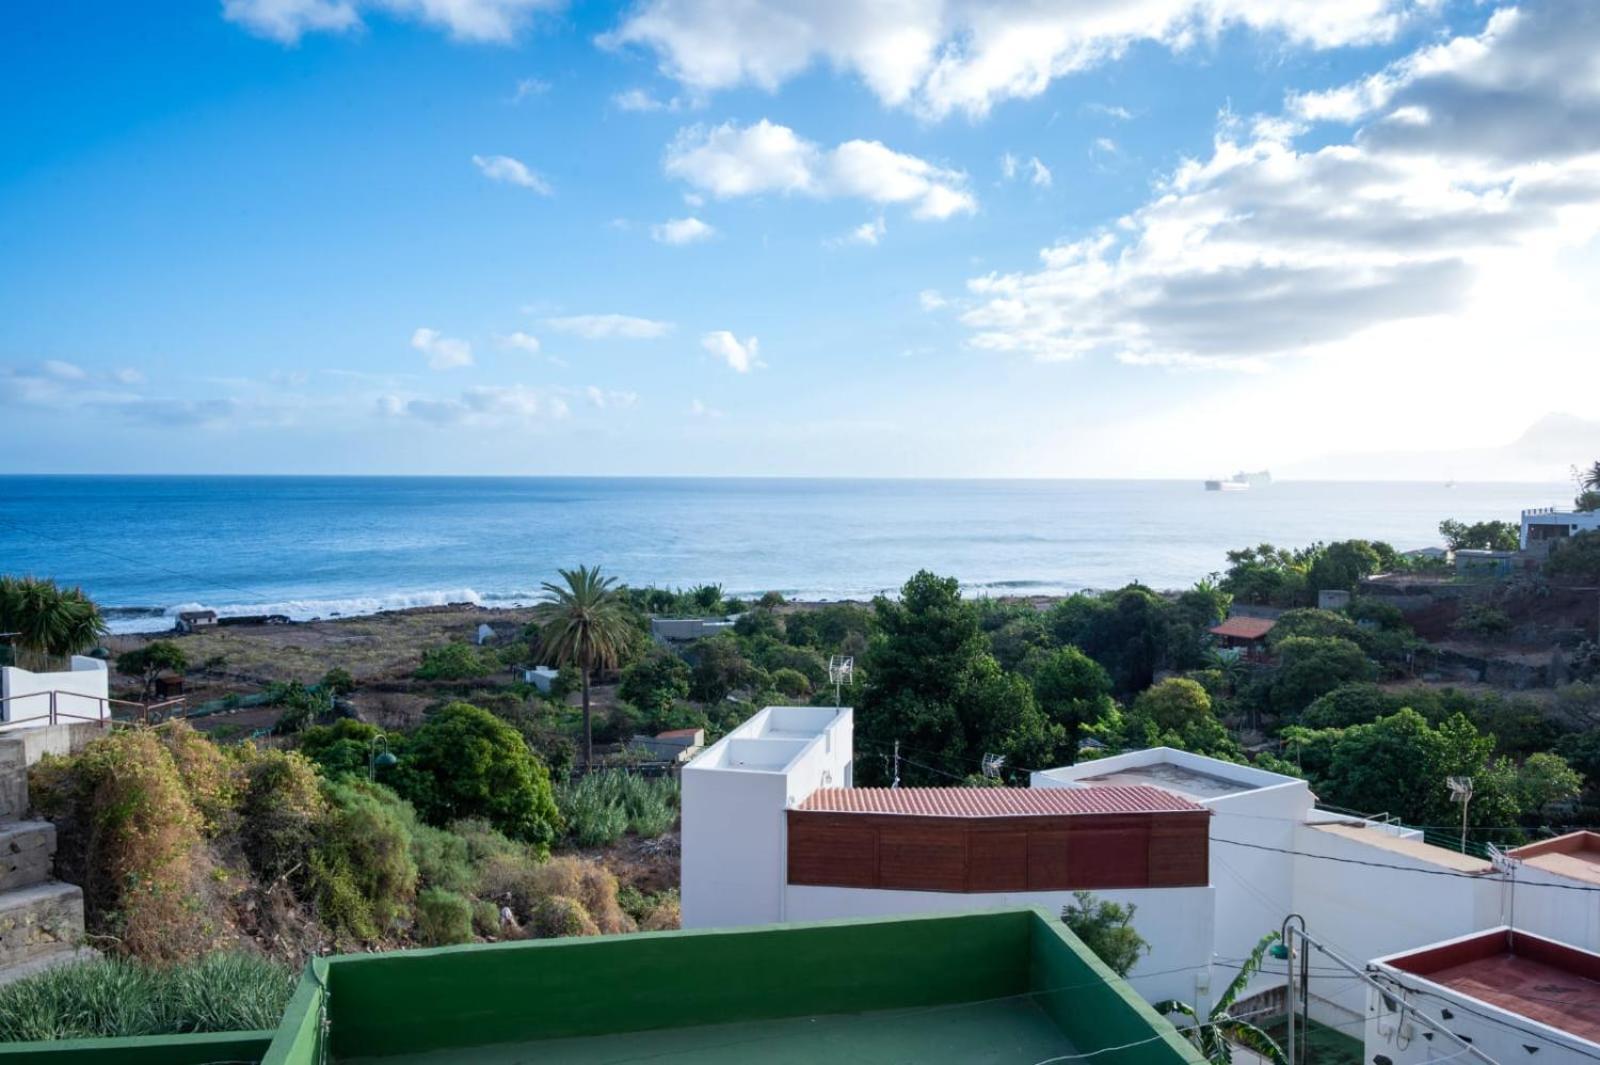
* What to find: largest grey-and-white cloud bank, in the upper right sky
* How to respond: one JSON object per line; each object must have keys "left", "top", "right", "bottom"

{"left": 963, "top": 0, "right": 1600, "bottom": 369}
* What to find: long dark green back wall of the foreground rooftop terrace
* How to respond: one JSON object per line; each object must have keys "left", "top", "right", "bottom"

{"left": 312, "top": 910, "right": 1034, "bottom": 1065}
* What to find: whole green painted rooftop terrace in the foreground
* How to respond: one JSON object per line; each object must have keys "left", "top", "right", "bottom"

{"left": 0, "top": 910, "right": 1202, "bottom": 1065}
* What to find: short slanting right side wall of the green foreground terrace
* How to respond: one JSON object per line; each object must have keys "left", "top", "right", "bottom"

{"left": 1029, "top": 910, "right": 1205, "bottom": 1065}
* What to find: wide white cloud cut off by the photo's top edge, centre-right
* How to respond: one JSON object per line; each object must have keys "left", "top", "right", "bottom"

{"left": 600, "top": 0, "right": 1435, "bottom": 118}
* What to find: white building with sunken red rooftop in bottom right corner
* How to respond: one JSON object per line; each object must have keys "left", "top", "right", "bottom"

{"left": 1365, "top": 926, "right": 1600, "bottom": 1065}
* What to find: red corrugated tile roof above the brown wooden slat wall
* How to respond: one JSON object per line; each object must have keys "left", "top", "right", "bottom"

{"left": 800, "top": 784, "right": 1206, "bottom": 817}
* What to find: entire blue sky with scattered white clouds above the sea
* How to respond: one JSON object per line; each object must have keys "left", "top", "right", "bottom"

{"left": 0, "top": 0, "right": 1600, "bottom": 477}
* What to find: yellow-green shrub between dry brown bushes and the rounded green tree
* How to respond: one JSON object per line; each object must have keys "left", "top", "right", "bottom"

{"left": 309, "top": 782, "right": 416, "bottom": 940}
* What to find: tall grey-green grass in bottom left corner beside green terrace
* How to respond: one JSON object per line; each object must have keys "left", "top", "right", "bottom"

{"left": 0, "top": 953, "right": 294, "bottom": 1043}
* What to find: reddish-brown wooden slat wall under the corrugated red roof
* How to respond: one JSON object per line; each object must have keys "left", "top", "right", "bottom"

{"left": 789, "top": 809, "right": 1210, "bottom": 892}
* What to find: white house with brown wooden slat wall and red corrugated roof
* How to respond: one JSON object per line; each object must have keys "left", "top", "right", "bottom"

{"left": 682, "top": 707, "right": 1216, "bottom": 1003}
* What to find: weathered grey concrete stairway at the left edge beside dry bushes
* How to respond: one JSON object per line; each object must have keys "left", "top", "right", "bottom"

{"left": 0, "top": 726, "right": 96, "bottom": 983}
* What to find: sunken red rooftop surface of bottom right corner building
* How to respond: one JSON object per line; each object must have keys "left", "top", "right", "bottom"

{"left": 1386, "top": 927, "right": 1600, "bottom": 1043}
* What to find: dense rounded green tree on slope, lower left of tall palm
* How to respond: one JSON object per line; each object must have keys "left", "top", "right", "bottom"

{"left": 392, "top": 702, "right": 562, "bottom": 851}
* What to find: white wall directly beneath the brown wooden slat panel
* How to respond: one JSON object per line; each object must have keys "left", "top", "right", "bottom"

{"left": 787, "top": 884, "right": 1209, "bottom": 1012}
